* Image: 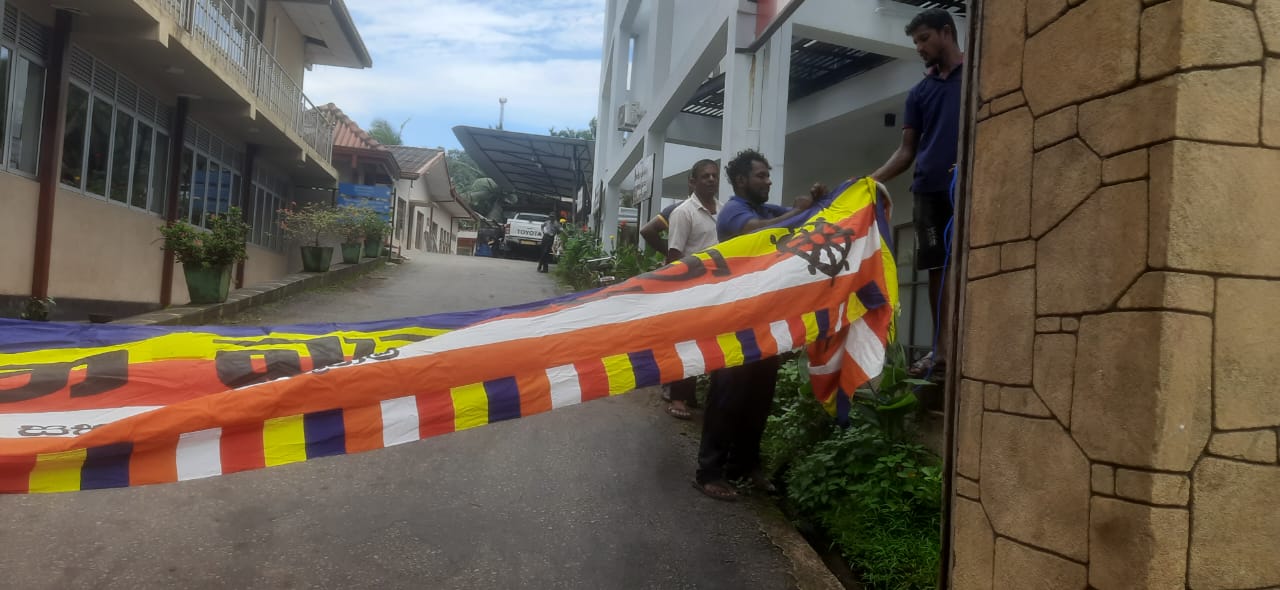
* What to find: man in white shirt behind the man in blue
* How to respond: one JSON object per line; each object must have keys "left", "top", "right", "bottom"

{"left": 667, "top": 160, "right": 719, "bottom": 420}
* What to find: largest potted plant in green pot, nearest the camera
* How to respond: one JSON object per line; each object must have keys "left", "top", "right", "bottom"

{"left": 160, "top": 207, "right": 250, "bottom": 303}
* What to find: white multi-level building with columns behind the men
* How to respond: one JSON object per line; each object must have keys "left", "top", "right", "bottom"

{"left": 590, "top": 0, "right": 968, "bottom": 349}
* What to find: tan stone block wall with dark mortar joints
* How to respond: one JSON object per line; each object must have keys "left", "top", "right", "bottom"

{"left": 951, "top": 0, "right": 1280, "bottom": 590}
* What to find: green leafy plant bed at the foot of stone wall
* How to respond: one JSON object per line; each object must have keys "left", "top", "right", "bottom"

{"left": 762, "top": 349, "right": 942, "bottom": 590}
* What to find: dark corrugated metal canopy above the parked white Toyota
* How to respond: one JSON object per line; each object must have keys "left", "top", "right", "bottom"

{"left": 453, "top": 125, "right": 595, "bottom": 198}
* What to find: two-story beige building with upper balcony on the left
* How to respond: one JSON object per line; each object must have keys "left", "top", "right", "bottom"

{"left": 0, "top": 0, "right": 371, "bottom": 319}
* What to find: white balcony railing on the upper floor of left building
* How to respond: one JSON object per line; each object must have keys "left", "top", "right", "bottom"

{"left": 164, "top": 0, "right": 334, "bottom": 163}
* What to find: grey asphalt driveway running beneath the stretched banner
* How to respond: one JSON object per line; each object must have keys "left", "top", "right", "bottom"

{"left": 0, "top": 255, "right": 795, "bottom": 589}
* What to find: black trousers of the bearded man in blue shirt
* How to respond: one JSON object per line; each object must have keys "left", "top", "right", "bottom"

{"left": 698, "top": 357, "right": 778, "bottom": 484}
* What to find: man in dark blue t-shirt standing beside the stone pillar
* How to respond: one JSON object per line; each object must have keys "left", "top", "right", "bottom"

{"left": 870, "top": 8, "right": 964, "bottom": 375}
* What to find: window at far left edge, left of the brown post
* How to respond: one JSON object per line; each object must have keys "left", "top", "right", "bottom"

{"left": 0, "top": 5, "right": 49, "bottom": 175}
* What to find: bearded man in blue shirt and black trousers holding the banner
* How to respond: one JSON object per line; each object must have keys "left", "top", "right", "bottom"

{"left": 694, "top": 150, "right": 817, "bottom": 500}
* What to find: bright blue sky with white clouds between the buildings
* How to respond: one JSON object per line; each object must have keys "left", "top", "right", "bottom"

{"left": 305, "top": 0, "right": 604, "bottom": 147}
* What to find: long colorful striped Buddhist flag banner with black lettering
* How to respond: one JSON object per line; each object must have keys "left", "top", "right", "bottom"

{"left": 0, "top": 180, "right": 897, "bottom": 493}
